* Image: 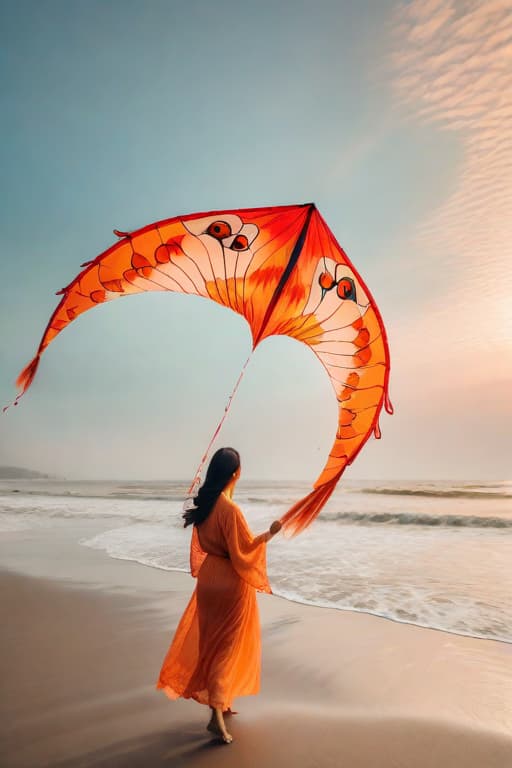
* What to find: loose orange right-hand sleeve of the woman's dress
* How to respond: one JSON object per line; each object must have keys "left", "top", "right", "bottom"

{"left": 219, "top": 501, "right": 272, "bottom": 594}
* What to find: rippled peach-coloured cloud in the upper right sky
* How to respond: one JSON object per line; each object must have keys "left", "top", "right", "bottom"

{"left": 391, "top": 0, "right": 512, "bottom": 364}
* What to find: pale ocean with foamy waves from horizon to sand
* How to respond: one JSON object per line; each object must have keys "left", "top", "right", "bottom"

{"left": 0, "top": 480, "right": 512, "bottom": 642}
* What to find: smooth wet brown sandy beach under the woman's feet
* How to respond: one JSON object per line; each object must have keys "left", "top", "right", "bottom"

{"left": 0, "top": 525, "right": 512, "bottom": 768}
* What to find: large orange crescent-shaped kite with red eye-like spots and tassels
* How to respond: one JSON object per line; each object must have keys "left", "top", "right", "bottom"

{"left": 7, "top": 203, "right": 393, "bottom": 534}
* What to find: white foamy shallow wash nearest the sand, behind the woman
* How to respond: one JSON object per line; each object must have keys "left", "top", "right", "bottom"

{"left": 82, "top": 523, "right": 512, "bottom": 642}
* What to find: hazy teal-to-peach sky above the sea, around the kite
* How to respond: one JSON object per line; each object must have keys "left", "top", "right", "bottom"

{"left": 0, "top": 0, "right": 512, "bottom": 483}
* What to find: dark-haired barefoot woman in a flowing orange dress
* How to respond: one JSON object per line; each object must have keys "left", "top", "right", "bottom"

{"left": 157, "top": 448, "right": 281, "bottom": 744}
